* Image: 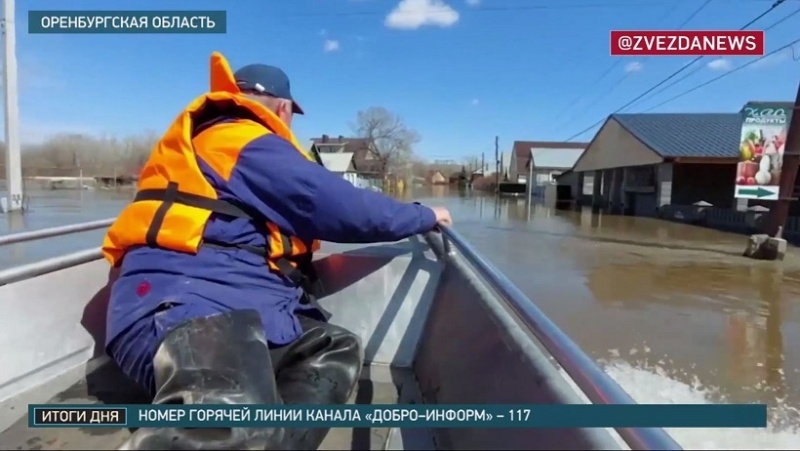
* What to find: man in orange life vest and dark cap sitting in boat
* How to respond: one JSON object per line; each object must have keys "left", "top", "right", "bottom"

{"left": 103, "top": 53, "right": 451, "bottom": 450}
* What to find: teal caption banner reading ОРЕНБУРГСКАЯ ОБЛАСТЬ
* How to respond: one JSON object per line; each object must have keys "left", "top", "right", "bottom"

{"left": 28, "top": 11, "right": 227, "bottom": 34}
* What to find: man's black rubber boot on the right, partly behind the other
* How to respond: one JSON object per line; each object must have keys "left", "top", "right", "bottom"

{"left": 276, "top": 320, "right": 364, "bottom": 451}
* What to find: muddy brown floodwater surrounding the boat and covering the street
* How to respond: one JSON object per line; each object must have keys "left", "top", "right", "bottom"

{"left": 0, "top": 187, "right": 800, "bottom": 449}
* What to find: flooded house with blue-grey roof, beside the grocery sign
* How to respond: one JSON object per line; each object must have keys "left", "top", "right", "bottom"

{"left": 562, "top": 113, "right": 747, "bottom": 216}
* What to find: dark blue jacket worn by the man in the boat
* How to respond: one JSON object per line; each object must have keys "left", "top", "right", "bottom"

{"left": 106, "top": 124, "right": 436, "bottom": 354}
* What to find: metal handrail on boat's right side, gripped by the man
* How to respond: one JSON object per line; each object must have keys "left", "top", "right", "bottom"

{"left": 441, "top": 227, "right": 683, "bottom": 450}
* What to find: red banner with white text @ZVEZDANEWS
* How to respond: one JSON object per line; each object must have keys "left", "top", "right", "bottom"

{"left": 610, "top": 30, "right": 765, "bottom": 56}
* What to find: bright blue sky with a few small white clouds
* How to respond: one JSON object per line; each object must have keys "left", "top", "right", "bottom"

{"left": 10, "top": 0, "right": 800, "bottom": 159}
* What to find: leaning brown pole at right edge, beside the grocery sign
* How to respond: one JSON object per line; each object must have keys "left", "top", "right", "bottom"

{"left": 766, "top": 81, "right": 800, "bottom": 238}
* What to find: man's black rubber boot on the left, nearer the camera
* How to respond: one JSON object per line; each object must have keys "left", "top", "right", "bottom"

{"left": 119, "top": 310, "right": 284, "bottom": 450}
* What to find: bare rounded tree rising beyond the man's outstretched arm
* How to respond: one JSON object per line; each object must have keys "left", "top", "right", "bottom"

{"left": 353, "top": 107, "right": 420, "bottom": 177}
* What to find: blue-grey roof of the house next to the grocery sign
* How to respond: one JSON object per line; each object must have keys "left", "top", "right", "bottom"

{"left": 611, "top": 113, "right": 742, "bottom": 158}
